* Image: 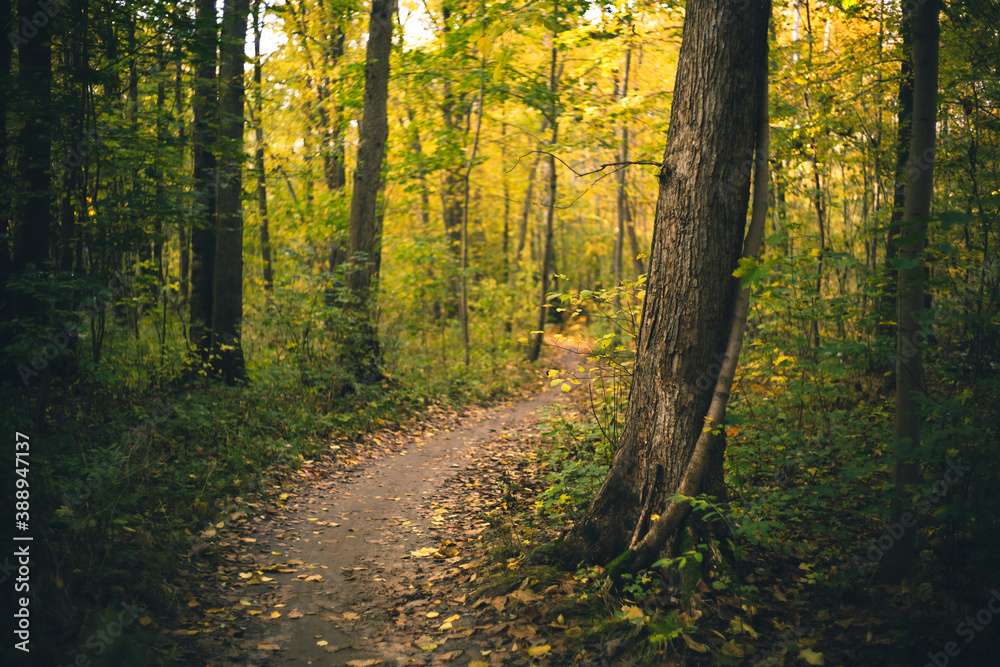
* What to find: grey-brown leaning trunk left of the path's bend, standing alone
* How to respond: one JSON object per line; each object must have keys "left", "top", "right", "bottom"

{"left": 347, "top": 0, "right": 396, "bottom": 382}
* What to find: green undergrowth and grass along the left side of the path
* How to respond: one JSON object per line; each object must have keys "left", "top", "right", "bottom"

{"left": 0, "top": 310, "right": 532, "bottom": 667}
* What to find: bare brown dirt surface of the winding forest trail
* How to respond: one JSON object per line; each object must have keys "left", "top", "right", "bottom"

{"left": 231, "top": 378, "right": 565, "bottom": 666}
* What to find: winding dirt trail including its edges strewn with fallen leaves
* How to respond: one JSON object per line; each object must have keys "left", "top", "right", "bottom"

{"left": 195, "top": 370, "right": 566, "bottom": 667}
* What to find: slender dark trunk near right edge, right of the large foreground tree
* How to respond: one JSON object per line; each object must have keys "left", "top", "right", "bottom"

{"left": 880, "top": 0, "right": 940, "bottom": 582}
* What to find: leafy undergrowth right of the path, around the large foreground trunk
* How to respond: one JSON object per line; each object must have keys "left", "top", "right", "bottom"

{"left": 493, "top": 316, "right": 1000, "bottom": 665}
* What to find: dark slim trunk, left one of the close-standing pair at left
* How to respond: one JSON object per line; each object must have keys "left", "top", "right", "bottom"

{"left": 189, "top": 0, "right": 219, "bottom": 363}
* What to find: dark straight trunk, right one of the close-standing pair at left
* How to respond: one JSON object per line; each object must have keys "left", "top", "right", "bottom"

{"left": 212, "top": 0, "right": 250, "bottom": 384}
